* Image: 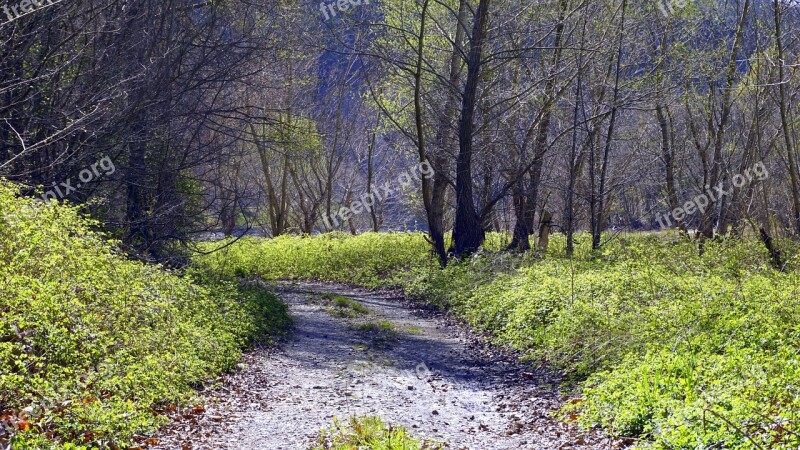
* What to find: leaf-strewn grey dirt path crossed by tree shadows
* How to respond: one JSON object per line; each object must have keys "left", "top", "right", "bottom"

{"left": 158, "top": 283, "right": 619, "bottom": 450}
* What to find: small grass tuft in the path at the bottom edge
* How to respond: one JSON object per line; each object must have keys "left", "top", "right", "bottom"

{"left": 313, "top": 417, "right": 444, "bottom": 450}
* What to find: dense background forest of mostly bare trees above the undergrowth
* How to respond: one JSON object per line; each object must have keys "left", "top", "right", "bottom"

{"left": 0, "top": 0, "right": 800, "bottom": 261}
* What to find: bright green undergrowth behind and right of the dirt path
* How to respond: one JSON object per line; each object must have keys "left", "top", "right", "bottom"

{"left": 195, "top": 233, "right": 800, "bottom": 449}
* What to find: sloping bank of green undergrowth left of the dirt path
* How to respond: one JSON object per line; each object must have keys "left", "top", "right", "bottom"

{"left": 0, "top": 181, "right": 288, "bottom": 449}
